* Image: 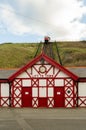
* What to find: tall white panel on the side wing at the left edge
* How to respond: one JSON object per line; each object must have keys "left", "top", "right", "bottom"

{"left": 1, "top": 83, "right": 9, "bottom": 97}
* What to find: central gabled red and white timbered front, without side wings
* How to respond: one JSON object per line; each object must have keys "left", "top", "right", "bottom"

{"left": 9, "top": 53, "right": 78, "bottom": 107}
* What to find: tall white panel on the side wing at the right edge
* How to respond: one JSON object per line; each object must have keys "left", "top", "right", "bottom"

{"left": 78, "top": 82, "right": 86, "bottom": 96}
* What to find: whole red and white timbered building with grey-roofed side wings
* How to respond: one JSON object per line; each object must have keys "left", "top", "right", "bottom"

{"left": 0, "top": 53, "right": 86, "bottom": 108}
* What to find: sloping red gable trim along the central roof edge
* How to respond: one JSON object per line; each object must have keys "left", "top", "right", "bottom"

{"left": 9, "top": 52, "right": 78, "bottom": 81}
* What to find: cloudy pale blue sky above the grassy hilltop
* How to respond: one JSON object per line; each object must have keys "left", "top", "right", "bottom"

{"left": 0, "top": 0, "right": 86, "bottom": 43}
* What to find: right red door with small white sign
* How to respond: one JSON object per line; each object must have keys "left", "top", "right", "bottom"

{"left": 54, "top": 87, "right": 64, "bottom": 107}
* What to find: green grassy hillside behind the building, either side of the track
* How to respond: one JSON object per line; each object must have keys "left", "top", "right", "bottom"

{"left": 0, "top": 41, "right": 86, "bottom": 68}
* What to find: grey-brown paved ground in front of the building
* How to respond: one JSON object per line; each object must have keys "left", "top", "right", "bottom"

{"left": 0, "top": 108, "right": 86, "bottom": 130}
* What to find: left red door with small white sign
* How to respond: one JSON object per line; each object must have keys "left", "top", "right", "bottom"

{"left": 22, "top": 87, "right": 32, "bottom": 107}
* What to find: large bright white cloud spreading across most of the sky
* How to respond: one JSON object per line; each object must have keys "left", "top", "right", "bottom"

{"left": 1, "top": 0, "right": 86, "bottom": 40}
